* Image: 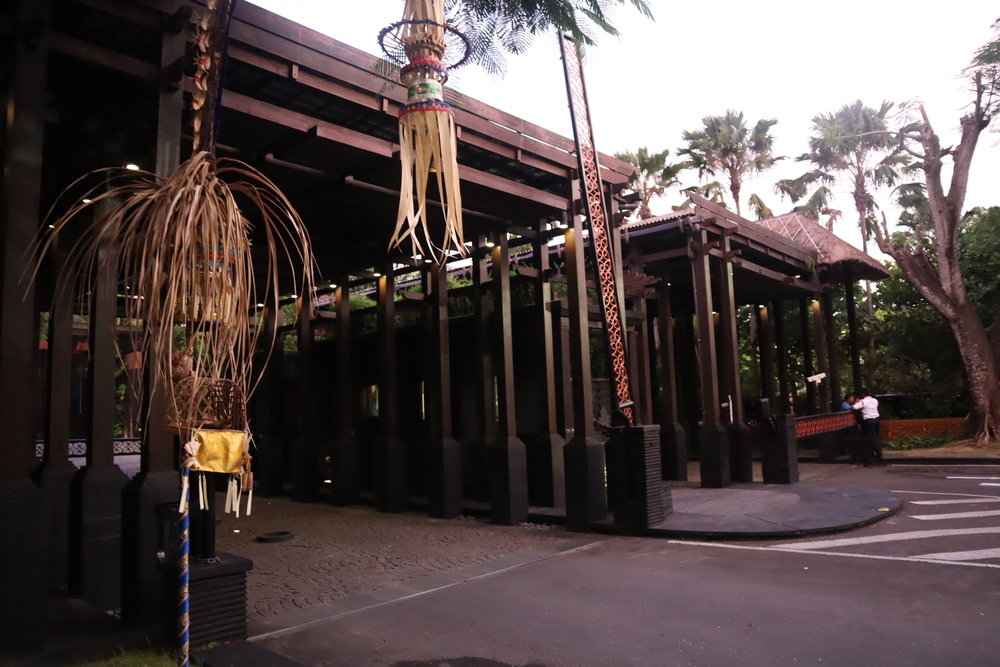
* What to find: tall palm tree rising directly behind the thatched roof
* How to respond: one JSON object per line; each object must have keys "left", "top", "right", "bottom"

{"left": 775, "top": 100, "right": 908, "bottom": 252}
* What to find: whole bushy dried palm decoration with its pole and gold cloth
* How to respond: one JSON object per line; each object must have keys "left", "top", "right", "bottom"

{"left": 35, "top": 0, "right": 314, "bottom": 512}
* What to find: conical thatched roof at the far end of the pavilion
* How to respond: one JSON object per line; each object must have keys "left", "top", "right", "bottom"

{"left": 756, "top": 212, "right": 889, "bottom": 282}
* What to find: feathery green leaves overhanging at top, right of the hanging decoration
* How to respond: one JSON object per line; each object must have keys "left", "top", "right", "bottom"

{"left": 445, "top": 0, "right": 653, "bottom": 74}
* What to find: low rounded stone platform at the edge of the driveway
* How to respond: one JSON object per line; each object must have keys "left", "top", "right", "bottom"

{"left": 594, "top": 482, "right": 900, "bottom": 539}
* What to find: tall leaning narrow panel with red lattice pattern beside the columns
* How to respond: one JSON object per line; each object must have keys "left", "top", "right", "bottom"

{"left": 559, "top": 35, "right": 634, "bottom": 426}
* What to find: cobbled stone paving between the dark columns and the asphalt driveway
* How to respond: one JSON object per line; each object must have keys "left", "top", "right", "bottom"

{"left": 216, "top": 496, "right": 579, "bottom": 621}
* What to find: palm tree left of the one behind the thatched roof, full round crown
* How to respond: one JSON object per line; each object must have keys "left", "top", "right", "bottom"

{"left": 678, "top": 110, "right": 781, "bottom": 214}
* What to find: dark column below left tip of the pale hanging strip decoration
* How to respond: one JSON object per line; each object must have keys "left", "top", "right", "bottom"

{"left": 374, "top": 261, "right": 406, "bottom": 512}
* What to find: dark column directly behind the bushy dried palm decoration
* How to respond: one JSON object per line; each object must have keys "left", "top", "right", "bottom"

{"left": 122, "top": 13, "right": 187, "bottom": 627}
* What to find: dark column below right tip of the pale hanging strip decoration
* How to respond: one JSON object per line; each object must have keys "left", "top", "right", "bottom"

{"left": 424, "top": 264, "right": 462, "bottom": 519}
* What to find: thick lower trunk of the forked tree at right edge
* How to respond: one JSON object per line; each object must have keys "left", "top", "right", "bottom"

{"left": 948, "top": 302, "right": 1000, "bottom": 443}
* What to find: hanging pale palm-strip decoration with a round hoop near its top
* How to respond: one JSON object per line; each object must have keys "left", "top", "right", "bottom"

{"left": 378, "top": 0, "right": 470, "bottom": 263}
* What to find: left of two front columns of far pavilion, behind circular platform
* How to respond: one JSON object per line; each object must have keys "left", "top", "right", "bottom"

{"left": 691, "top": 229, "right": 732, "bottom": 488}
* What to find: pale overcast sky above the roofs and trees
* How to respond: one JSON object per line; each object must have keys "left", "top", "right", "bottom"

{"left": 246, "top": 0, "right": 1000, "bottom": 252}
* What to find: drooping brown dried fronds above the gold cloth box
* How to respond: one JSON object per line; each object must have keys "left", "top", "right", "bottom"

{"left": 35, "top": 152, "right": 313, "bottom": 434}
